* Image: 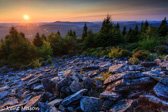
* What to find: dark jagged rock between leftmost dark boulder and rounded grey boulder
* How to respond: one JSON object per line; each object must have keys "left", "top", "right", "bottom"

{"left": 56, "top": 76, "right": 72, "bottom": 92}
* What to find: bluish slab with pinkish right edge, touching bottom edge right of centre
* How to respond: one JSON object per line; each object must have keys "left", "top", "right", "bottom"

{"left": 110, "top": 99, "right": 133, "bottom": 112}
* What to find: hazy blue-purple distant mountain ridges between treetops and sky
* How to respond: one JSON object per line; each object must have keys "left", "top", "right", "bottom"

{"left": 0, "top": 21, "right": 161, "bottom": 39}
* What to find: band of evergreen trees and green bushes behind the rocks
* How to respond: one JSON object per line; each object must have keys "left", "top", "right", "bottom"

{"left": 0, "top": 15, "right": 168, "bottom": 68}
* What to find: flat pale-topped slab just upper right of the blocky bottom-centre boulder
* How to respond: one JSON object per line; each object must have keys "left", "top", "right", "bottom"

{"left": 100, "top": 91, "right": 120, "bottom": 101}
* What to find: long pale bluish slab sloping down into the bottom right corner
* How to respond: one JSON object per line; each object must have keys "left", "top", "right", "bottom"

{"left": 139, "top": 95, "right": 168, "bottom": 108}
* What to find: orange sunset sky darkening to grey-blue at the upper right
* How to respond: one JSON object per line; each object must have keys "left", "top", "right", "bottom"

{"left": 0, "top": 0, "right": 168, "bottom": 23}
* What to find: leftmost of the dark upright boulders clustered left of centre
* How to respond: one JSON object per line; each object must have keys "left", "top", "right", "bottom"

{"left": 41, "top": 78, "right": 56, "bottom": 93}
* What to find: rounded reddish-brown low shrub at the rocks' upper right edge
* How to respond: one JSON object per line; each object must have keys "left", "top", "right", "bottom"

{"left": 132, "top": 50, "right": 149, "bottom": 60}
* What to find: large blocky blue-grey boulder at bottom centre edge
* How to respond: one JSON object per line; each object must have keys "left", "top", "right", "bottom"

{"left": 80, "top": 96, "right": 102, "bottom": 112}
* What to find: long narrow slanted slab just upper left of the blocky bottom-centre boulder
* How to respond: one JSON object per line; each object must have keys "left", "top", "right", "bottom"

{"left": 62, "top": 89, "right": 88, "bottom": 106}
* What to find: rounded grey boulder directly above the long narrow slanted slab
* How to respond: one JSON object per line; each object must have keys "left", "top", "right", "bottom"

{"left": 69, "top": 81, "right": 82, "bottom": 93}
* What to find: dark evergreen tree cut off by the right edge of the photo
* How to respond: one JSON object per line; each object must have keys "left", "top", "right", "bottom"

{"left": 159, "top": 17, "right": 168, "bottom": 36}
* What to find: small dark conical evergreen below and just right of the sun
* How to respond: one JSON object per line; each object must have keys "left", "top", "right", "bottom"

{"left": 33, "top": 33, "right": 43, "bottom": 47}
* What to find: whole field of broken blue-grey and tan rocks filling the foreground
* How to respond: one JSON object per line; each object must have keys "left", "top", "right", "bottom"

{"left": 0, "top": 56, "right": 168, "bottom": 112}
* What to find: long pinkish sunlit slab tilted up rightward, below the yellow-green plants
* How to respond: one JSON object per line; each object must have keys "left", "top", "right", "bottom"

{"left": 104, "top": 72, "right": 125, "bottom": 84}
